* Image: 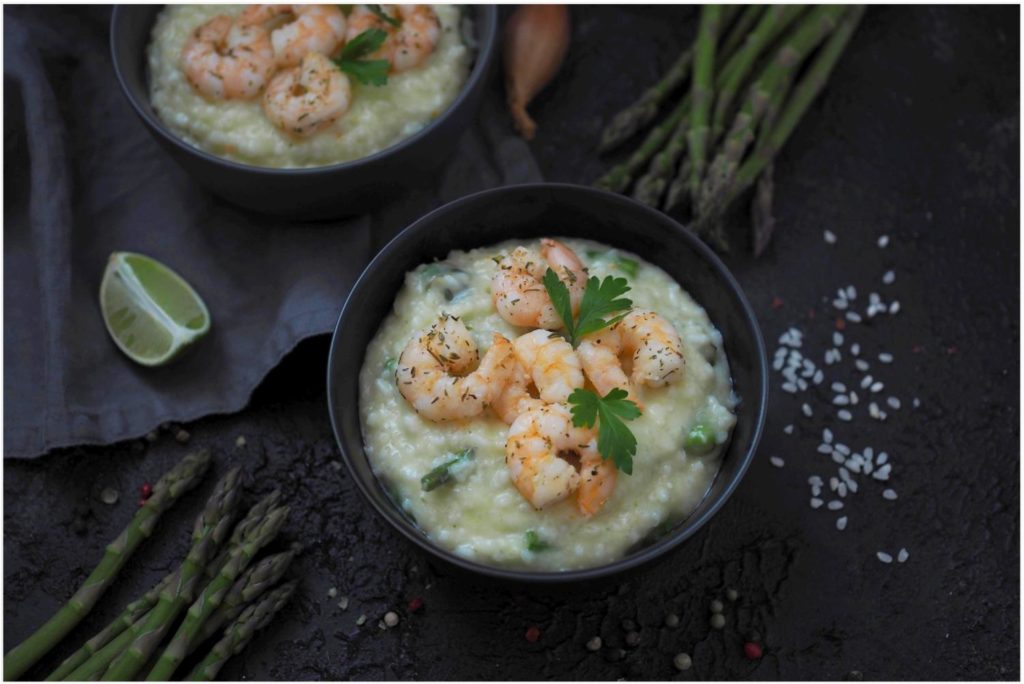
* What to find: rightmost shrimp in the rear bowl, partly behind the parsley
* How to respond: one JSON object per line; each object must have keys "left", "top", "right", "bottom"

{"left": 348, "top": 5, "right": 441, "bottom": 73}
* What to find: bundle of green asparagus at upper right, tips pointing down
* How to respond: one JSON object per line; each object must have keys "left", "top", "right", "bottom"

{"left": 595, "top": 5, "right": 864, "bottom": 255}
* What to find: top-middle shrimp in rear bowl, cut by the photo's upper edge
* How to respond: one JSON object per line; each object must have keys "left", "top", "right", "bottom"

{"left": 239, "top": 5, "right": 346, "bottom": 69}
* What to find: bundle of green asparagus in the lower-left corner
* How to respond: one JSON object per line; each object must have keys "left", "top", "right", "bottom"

{"left": 4, "top": 452, "right": 299, "bottom": 681}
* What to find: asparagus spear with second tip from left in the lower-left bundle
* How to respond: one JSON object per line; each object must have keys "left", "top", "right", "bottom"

{"left": 98, "top": 468, "right": 242, "bottom": 680}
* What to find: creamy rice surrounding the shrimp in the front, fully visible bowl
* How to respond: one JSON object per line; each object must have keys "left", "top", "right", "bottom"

{"left": 359, "top": 240, "right": 736, "bottom": 570}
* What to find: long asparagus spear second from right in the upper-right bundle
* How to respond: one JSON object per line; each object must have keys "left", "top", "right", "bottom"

{"left": 695, "top": 5, "right": 846, "bottom": 217}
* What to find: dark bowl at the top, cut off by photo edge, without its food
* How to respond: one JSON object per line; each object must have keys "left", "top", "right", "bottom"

{"left": 111, "top": 5, "right": 498, "bottom": 218}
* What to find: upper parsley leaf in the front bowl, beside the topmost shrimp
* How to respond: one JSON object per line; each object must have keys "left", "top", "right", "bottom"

{"left": 543, "top": 268, "right": 633, "bottom": 347}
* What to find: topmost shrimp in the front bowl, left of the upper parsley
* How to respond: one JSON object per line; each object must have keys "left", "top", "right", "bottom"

{"left": 490, "top": 239, "right": 587, "bottom": 330}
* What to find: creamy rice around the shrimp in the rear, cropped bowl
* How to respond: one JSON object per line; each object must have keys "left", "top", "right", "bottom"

{"left": 147, "top": 5, "right": 472, "bottom": 168}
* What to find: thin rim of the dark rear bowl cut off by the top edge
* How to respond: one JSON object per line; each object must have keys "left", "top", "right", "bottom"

{"left": 110, "top": 5, "right": 498, "bottom": 177}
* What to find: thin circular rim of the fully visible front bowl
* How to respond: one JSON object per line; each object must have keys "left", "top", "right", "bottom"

{"left": 327, "top": 182, "right": 769, "bottom": 585}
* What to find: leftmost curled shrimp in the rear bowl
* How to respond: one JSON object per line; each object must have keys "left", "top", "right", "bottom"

{"left": 181, "top": 14, "right": 274, "bottom": 99}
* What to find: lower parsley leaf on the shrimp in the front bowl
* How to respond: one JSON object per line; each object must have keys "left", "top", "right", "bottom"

{"left": 568, "top": 385, "right": 642, "bottom": 475}
